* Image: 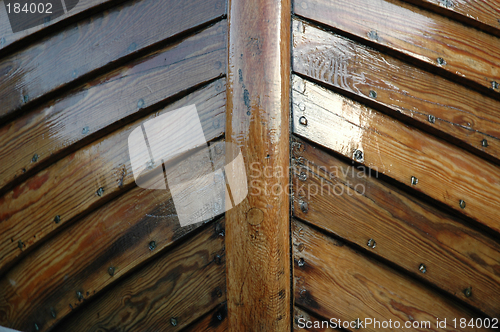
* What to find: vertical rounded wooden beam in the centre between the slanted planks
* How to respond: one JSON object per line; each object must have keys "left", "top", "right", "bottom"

{"left": 226, "top": 0, "right": 291, "bottom": 331}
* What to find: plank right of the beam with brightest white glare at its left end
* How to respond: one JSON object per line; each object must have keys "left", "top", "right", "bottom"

{"left": 293, "top": 77, "right": 500, "bottom": 236}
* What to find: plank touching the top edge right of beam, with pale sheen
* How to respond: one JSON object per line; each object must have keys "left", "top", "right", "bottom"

{"left": 294, "top": 0, "right": 500, "bottom": 97}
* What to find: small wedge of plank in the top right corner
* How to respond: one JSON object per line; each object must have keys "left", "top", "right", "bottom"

{"left": 404, "top": 0, "right": 500, "bottom": 37}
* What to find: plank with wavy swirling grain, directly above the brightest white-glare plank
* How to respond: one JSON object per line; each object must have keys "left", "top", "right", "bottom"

{"left": 293, "top": 20, "right": 500, "bottom": 163}
